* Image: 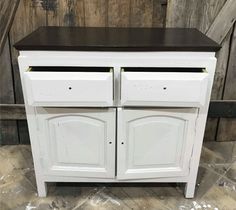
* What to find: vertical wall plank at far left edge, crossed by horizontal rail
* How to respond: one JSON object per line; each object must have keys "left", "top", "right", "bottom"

{"left": 0, "top": 40, "right": 19, "bottom": 145}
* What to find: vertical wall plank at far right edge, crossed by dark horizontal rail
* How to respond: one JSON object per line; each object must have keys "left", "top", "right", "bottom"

{"left": 217, "top": 24, "right": 236, "bottom": 141}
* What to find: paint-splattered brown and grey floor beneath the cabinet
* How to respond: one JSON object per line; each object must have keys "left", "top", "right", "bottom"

{"left": 0, "top": 142, "right": 236, "bottom": 210}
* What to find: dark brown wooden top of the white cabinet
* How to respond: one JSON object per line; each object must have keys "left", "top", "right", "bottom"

{"left": 14, "top": 27, "right": 220, "bottom": 52}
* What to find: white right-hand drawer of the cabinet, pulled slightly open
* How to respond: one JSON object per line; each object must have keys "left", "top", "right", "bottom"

{"left": 121, "top": 68, "right": 208, "bottom": 107}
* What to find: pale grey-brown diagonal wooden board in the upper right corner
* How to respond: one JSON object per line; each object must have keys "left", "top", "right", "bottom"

{"left": 206, "top": 0, "right": 236, "bottom": 43}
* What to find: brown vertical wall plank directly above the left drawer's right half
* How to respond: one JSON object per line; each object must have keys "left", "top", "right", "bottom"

{"left": 84, "top": 0, "right": 108, "bottom": 27}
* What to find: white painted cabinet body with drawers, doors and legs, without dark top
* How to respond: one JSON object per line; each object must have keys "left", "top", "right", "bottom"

{"left": 19, "top": 51, "right": 216, "bottom": 198}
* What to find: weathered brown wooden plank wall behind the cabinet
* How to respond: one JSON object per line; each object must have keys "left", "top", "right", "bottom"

{"left": 0, "top": 0, "right": 236, "bottom": 144}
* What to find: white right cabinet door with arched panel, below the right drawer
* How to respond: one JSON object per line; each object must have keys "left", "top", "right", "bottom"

{"left": 117, "top": 108, "right": 197, "bottom": 179}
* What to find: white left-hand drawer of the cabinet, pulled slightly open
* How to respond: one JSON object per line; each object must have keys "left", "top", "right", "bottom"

{"left": 24, "top": 67, "right": 113, "bottom": 106}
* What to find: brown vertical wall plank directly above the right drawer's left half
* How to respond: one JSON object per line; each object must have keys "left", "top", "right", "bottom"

{"left": 129, "top": 0, "right": 153, "bottom": 27}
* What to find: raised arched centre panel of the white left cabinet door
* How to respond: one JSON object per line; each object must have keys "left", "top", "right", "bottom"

{"left": 48, "top": 116, "right": 107, "bottom": 167}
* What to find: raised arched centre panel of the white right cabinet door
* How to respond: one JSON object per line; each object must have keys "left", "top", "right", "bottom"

{"left": 127, "top": 116, "right": 185, "bottom": 168}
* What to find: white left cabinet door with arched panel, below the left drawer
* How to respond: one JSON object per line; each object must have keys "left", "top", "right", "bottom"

{"left": 36, "top": 108, "right": 116, "bottom": 178}
